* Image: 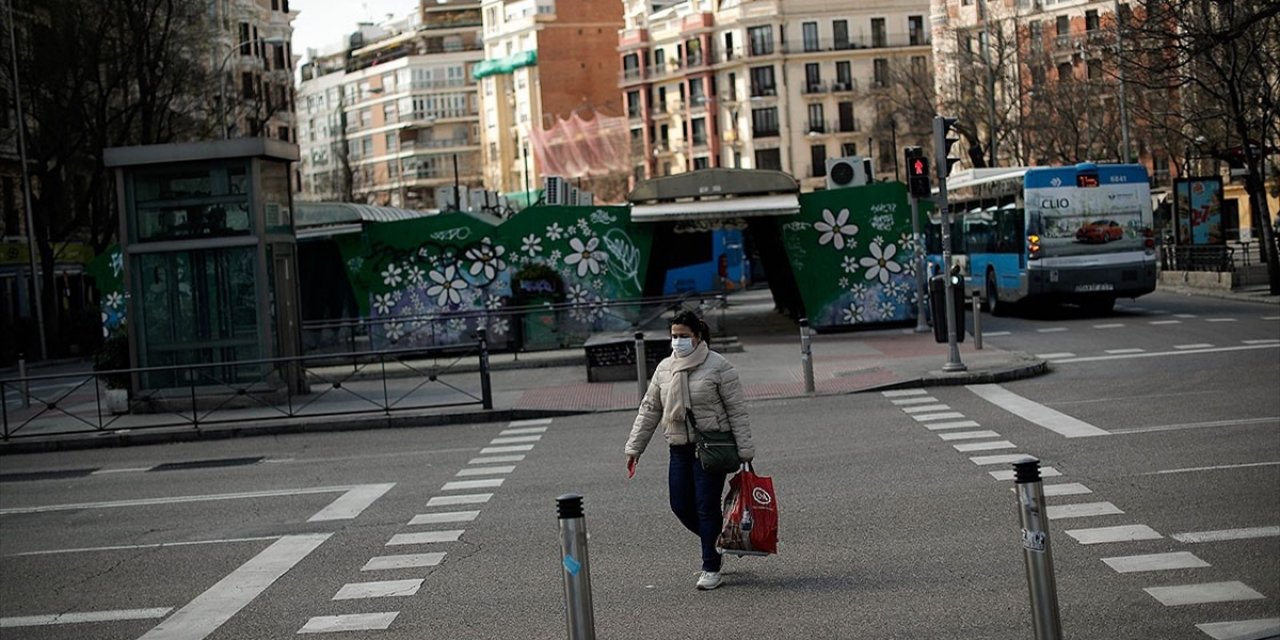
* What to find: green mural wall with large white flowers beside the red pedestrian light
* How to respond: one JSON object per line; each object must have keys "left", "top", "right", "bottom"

{"left": 782, "top": 183, "right": 923, "bottom": 328}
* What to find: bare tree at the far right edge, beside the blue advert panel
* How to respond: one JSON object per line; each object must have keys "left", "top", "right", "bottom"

{"left": 1121, "top": 0, "right": 1280, "bottom": 294}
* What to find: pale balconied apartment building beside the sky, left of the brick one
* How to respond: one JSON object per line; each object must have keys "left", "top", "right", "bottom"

{"left": 298, "top": 0, "right": 484, "bottom": 209}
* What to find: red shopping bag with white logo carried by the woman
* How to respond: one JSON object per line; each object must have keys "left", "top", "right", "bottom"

{"left": 716, "top": 463, "right": 778, "bottom": 556}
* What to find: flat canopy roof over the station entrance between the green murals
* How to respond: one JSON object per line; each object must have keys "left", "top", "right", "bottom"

{"left": 627, "top": 169, "right": 800, "bottom": 223}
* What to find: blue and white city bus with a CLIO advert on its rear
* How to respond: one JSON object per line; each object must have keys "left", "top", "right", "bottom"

{"left": 927, "top": 163, "right": 1156, "bottom": 315}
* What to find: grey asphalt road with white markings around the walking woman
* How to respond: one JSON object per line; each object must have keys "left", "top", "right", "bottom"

{"left": 0, "top": 294, "right": 1280, "bottom": 640}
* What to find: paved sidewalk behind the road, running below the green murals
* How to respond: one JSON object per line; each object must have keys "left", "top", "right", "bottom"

{"left": 0, "top": 289, "right": 1046, "bottom": 454}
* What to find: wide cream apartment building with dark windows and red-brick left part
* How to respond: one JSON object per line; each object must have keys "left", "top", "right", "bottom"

{"left": 618, "top": 0, "right": 932, "bottom": 191}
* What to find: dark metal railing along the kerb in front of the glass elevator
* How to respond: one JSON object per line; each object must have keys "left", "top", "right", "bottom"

{"left": 0, "top": 330, "right": 493, "bottom": 442}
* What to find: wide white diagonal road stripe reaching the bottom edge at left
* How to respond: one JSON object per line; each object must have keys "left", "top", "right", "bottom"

{"left": 138, "top": 534, "right": 333, "bottom": 640}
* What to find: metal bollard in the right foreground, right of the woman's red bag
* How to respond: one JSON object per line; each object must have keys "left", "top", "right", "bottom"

{"left": 1014, "top": 456, "right": 1062, "bottom": 640}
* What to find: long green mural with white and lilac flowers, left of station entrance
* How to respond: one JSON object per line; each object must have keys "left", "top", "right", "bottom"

{"left": 339, "top": 207, "right": 652, "bottom": 348}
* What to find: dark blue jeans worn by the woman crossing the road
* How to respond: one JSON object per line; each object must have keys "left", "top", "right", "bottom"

{"left": 667, "top": 444, "right": 726, "bottom": 571}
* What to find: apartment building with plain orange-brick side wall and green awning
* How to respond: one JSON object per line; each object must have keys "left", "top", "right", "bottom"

{"left": 474, "top": 0, "right": 622, "bottom": 199}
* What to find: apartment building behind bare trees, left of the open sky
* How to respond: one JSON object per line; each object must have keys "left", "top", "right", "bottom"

{"left": 209, "top": 0, "right": 297, "bottom": 142}
